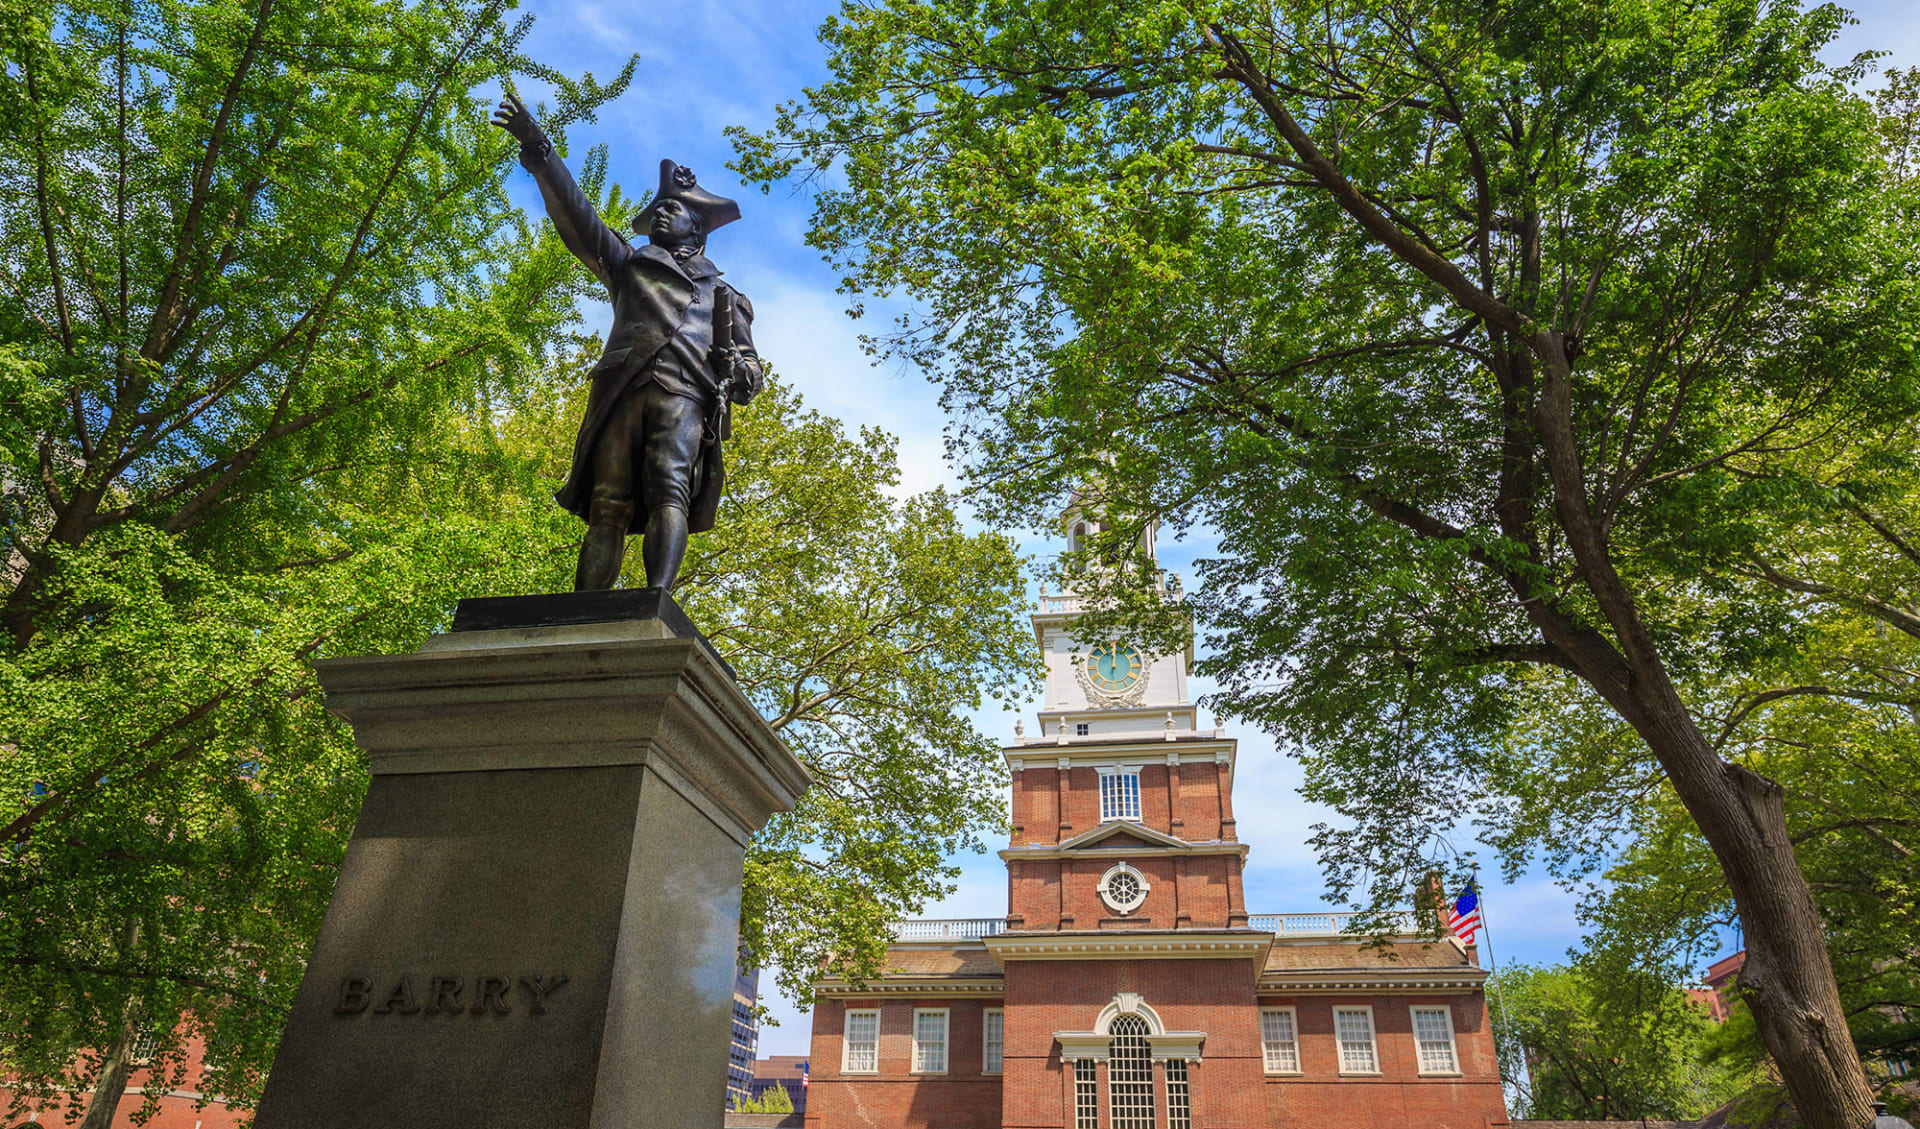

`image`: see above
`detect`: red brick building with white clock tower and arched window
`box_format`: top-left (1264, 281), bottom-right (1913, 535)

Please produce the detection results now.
top-left (804, 509), bottom-right (1507, 1129)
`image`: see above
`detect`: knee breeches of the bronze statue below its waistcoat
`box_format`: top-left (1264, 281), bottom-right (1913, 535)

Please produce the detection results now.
top-left (589, 380), bottom-right (707, 520)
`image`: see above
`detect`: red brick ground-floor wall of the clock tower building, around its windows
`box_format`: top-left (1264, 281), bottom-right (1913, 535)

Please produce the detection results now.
top-left (806, 975), bottom-right (1507, 1129)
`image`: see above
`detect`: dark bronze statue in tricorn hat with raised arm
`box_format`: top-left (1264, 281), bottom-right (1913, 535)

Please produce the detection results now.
top-left (493, 94), bottom-right (762, 591)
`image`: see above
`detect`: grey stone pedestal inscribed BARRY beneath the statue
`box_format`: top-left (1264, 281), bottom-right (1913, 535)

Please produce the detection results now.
top-left (255, 589), bottom-right (808, 1129)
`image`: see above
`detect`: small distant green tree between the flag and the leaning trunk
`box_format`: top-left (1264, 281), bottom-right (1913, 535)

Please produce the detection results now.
top-left (1488, 964), bottom-right (1757, 1121)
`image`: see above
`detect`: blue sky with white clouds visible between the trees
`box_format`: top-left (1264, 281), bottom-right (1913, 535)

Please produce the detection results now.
top-left (511, 0), bottom-right (1920, 1054)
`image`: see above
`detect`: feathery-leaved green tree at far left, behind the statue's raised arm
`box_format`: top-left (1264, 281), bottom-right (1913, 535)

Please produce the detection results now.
top-left (0, 0), bottom-right (626, 1129)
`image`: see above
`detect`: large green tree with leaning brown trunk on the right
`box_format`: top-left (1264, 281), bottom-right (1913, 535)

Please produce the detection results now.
top-left (739, 0), bottom-right (1920, 1129)
